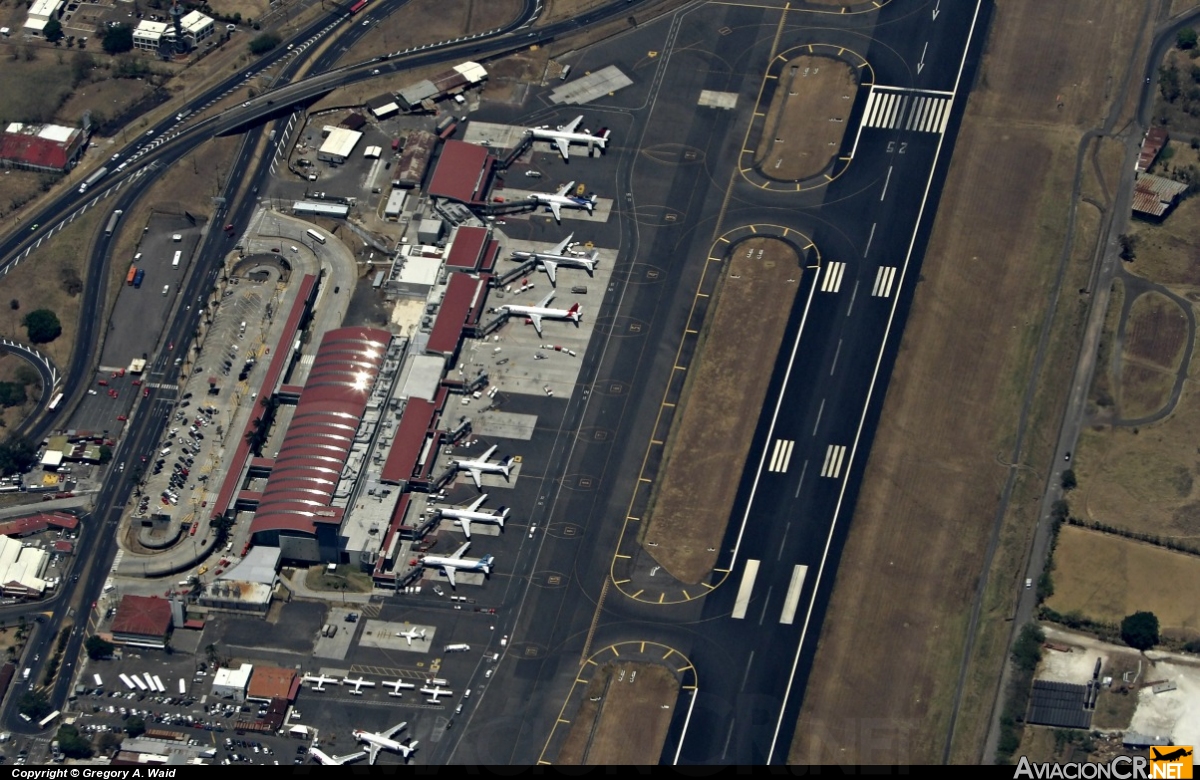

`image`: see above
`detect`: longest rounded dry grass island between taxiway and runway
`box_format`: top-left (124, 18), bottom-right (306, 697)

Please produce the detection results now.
top-left (641, 239), bottom-right (802, 584)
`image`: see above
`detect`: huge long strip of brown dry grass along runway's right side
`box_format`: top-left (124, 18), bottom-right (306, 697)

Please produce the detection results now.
top-left (791, 0), bottom-right (1141, 766)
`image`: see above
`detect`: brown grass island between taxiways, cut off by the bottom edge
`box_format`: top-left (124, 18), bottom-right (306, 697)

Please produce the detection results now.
top-left (556, 662), bottom-right (679, 767)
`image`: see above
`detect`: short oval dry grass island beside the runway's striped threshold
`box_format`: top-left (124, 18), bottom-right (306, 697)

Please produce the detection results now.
top-left (755, 55), bottom-right (858, 181)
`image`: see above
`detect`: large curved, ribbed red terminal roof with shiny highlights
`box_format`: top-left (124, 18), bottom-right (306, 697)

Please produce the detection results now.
top-left (250, 328), bottom-right (391, 534)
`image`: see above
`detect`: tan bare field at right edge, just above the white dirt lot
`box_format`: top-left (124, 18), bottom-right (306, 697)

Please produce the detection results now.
top-left (1046, 526), bottom-right (1200, 638)
